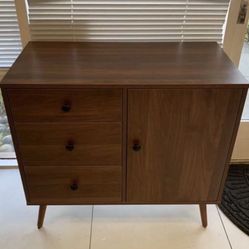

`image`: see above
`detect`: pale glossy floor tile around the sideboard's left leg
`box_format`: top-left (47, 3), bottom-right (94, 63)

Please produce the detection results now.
top-left (0, 170), bottom-right (92, 249)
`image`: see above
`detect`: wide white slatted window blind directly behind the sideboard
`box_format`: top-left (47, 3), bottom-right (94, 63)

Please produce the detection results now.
top-left (29, 0), bottom-right (229, 43)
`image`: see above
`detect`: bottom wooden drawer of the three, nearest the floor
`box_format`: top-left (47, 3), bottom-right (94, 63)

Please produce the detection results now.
top-left (25, 166), bottom-right (121, 205)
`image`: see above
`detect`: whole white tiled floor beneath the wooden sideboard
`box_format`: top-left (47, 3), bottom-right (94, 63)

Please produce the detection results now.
top-left (0, 169), bottom-right (249, 249)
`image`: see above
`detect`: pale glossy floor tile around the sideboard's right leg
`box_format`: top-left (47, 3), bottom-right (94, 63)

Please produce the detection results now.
top-left (91, 205), bottom-right (230, 249)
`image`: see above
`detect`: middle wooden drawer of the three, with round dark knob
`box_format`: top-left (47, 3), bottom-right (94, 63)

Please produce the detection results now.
top-left (15, 122), bottom-right (122, 166)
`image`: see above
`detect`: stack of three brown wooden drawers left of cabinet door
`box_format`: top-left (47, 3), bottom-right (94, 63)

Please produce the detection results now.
top-left (7, 89), bottom-right (122, 205)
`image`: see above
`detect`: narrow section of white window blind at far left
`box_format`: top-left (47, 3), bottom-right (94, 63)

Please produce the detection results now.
top-left (0, 0), bottom-right (22, 68)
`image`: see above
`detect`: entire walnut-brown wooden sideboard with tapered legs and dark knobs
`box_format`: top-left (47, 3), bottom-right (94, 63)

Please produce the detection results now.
top-left (1, 42), bottom-right (248, 228)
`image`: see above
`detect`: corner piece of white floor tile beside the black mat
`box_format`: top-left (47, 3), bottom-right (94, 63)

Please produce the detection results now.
top-left (219, 210), bottom-right (249, 249)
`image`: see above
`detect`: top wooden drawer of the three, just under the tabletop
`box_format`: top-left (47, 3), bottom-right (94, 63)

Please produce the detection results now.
top-left (8, 89), bottom-right (122, 122)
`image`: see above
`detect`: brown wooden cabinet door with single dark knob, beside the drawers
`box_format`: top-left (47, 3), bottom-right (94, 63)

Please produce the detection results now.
top-left (127, 88), bottom-right (242, 203)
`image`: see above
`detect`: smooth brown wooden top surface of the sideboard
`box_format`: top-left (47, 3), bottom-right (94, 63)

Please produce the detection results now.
top-left (1, 42), bottom-right (248, 88)
